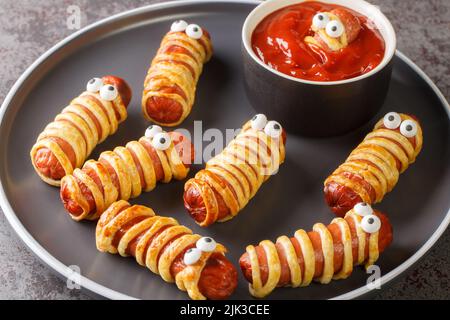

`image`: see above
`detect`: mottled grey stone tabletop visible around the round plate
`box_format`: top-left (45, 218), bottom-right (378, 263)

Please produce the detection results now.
top-left (0, 0), bottom-right (450, 299)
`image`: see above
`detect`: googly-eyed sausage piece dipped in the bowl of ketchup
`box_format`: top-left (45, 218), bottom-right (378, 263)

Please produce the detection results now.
top-left (305, 8), bottom-right (361, 51)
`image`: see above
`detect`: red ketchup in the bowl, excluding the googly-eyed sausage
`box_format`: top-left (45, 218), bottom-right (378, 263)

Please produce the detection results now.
top-left (252, 1), bottom-right (385, 81)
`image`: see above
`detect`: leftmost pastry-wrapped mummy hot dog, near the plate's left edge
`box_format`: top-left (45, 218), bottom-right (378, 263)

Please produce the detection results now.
top-left (30, 76), bottom-right (131, 186)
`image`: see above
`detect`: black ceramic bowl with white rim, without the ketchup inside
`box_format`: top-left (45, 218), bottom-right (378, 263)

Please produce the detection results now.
top-left (242, 0), bottom-right (397, 137)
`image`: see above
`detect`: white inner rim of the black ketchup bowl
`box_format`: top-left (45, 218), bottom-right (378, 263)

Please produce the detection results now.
top-left (242, 0), bottom-right (397, 86)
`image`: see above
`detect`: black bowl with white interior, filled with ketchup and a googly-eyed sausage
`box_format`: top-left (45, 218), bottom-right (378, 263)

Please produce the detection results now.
top-left (242, 0), bottom-right (397, 137)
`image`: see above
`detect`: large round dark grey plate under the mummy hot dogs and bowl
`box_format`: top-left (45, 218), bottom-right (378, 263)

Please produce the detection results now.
top-left (0, 1), bottom-right (450, 299)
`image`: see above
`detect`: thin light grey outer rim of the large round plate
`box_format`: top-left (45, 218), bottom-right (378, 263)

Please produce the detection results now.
top-left (0, 0), bottom-right (450, 300)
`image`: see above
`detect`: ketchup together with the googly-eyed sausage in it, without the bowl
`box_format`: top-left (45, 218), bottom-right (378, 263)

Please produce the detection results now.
top-left (252, 1), bottom-right (385, 81)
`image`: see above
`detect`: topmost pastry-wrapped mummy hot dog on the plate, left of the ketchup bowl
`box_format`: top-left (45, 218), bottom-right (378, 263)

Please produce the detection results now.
top-left (142, 20), bottom-right (212, 126)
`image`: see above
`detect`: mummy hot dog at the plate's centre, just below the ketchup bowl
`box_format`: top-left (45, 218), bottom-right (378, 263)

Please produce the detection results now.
top-left (184, 114), bottom-right (286, 227)
